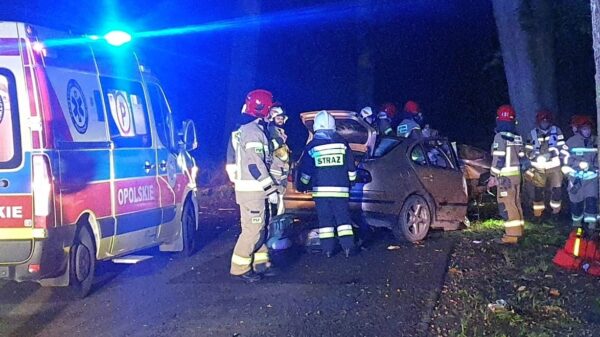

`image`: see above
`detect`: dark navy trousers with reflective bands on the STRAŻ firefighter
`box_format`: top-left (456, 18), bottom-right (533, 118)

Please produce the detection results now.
top-left (314, 198), bottom-right (354, 252)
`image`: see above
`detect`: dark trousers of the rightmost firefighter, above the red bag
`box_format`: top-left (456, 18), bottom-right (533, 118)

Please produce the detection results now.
top-left (568, 177), bottom-right (598, 230)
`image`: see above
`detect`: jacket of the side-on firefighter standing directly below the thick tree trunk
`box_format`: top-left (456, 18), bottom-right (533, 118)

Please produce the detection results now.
top-left (490, 131), bottom-right (525, 177)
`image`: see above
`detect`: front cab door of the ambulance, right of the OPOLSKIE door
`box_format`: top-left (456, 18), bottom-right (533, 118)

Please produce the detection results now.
top-left (146, 82), bottom-right (183, 242)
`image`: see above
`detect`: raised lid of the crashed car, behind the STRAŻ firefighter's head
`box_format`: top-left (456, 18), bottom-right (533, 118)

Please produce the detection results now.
top-left (300, 110), bottom-right (375, 155)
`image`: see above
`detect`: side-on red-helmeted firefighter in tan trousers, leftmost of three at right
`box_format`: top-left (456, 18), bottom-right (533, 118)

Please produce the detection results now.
top-left (489, 105), bottom-right (525, 244)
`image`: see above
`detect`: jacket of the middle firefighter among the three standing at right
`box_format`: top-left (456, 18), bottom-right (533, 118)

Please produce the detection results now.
top-left (525, 125), bottom-right (565, 171)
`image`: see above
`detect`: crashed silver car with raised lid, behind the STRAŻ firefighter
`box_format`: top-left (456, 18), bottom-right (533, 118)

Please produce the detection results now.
top-left (284, 110), bottom-right (468, 242)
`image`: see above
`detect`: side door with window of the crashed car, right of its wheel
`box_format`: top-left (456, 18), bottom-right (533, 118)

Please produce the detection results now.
top-left (409, 139), bottom-right (467, 221)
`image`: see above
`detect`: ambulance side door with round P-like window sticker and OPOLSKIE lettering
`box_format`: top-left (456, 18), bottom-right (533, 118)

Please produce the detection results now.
top-left (101, 77), bottom-right (162, 255)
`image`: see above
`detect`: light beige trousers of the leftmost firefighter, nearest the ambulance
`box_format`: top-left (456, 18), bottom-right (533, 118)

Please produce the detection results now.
top-left (230, 199), bottom-right (270, 275)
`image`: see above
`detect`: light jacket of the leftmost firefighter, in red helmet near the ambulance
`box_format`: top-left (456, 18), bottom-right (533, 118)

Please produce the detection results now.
top-left (226, 119), bottom-right (276, 202)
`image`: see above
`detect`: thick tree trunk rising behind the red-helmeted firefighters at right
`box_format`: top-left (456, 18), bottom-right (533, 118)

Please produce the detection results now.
top-left (492, 0), bottom-right (557, 135)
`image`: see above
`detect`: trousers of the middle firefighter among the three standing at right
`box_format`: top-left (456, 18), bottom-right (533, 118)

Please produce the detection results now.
top-left (533, 167), bottom-right (563, 217)
